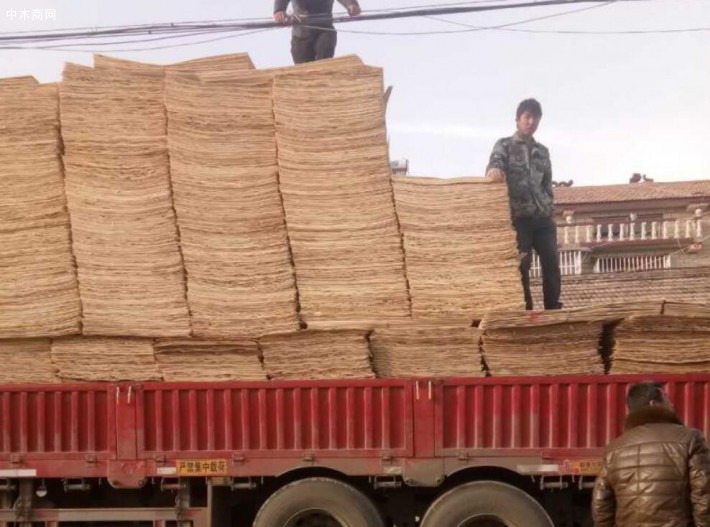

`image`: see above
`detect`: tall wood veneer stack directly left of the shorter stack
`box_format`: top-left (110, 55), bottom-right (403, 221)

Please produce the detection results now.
top-left (274, 66), bottom-right (410, 324)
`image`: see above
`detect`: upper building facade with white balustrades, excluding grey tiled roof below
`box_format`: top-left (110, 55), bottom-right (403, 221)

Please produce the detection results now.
top-left (533, 181), bottom-right (710, 276)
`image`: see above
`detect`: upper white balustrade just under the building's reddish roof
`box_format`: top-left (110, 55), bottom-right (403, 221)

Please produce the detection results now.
top-left (557, 218), bottom-right (703, 245)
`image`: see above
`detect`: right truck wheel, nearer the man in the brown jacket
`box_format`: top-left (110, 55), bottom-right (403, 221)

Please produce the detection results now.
top-left (421, 481), bottom-right (553, 527)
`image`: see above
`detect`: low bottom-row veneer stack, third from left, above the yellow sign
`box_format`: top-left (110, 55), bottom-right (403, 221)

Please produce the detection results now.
top-left (154, 339), bottom-right (266, 381)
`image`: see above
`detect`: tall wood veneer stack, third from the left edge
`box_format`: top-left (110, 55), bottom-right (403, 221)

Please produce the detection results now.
top-left (166, 72), bottom-right (299, 338)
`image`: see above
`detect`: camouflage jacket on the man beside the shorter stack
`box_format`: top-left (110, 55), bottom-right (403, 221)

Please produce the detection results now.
top-left (488, 134), bottom-right (555, 219)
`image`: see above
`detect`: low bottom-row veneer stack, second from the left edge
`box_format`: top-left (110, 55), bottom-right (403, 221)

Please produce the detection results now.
top-left (52, 337), bottom-right (162, 382)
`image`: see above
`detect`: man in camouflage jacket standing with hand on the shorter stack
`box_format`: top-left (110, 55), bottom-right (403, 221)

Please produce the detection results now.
top-left (486, 99), bottom-right (562, 310)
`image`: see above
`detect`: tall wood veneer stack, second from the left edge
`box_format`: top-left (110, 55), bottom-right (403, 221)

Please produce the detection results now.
top-left (60, 64), bottom-right (190, 337)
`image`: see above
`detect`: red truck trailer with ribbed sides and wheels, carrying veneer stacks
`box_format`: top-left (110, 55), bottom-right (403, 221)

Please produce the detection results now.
top-left (0, 374), bottom-right (710, 527)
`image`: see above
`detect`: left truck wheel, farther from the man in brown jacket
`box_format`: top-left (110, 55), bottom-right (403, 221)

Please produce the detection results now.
top-left (253, 478), bottom-right (385, 527)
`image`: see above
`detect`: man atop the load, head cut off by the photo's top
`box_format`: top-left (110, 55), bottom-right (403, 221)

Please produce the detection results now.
top-left (274, 0), bottom-right (360, 64)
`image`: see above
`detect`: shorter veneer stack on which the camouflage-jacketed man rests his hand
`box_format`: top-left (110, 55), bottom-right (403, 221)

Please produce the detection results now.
top-left (393, 176), bottom-right (524, 319)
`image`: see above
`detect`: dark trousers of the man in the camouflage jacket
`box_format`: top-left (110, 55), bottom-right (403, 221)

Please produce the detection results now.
top-left (513, 218), bottom-right (562, 310)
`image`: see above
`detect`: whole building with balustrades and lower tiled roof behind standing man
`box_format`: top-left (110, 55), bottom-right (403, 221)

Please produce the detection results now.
top-left (532, 180), bottom-right (710, 308)
